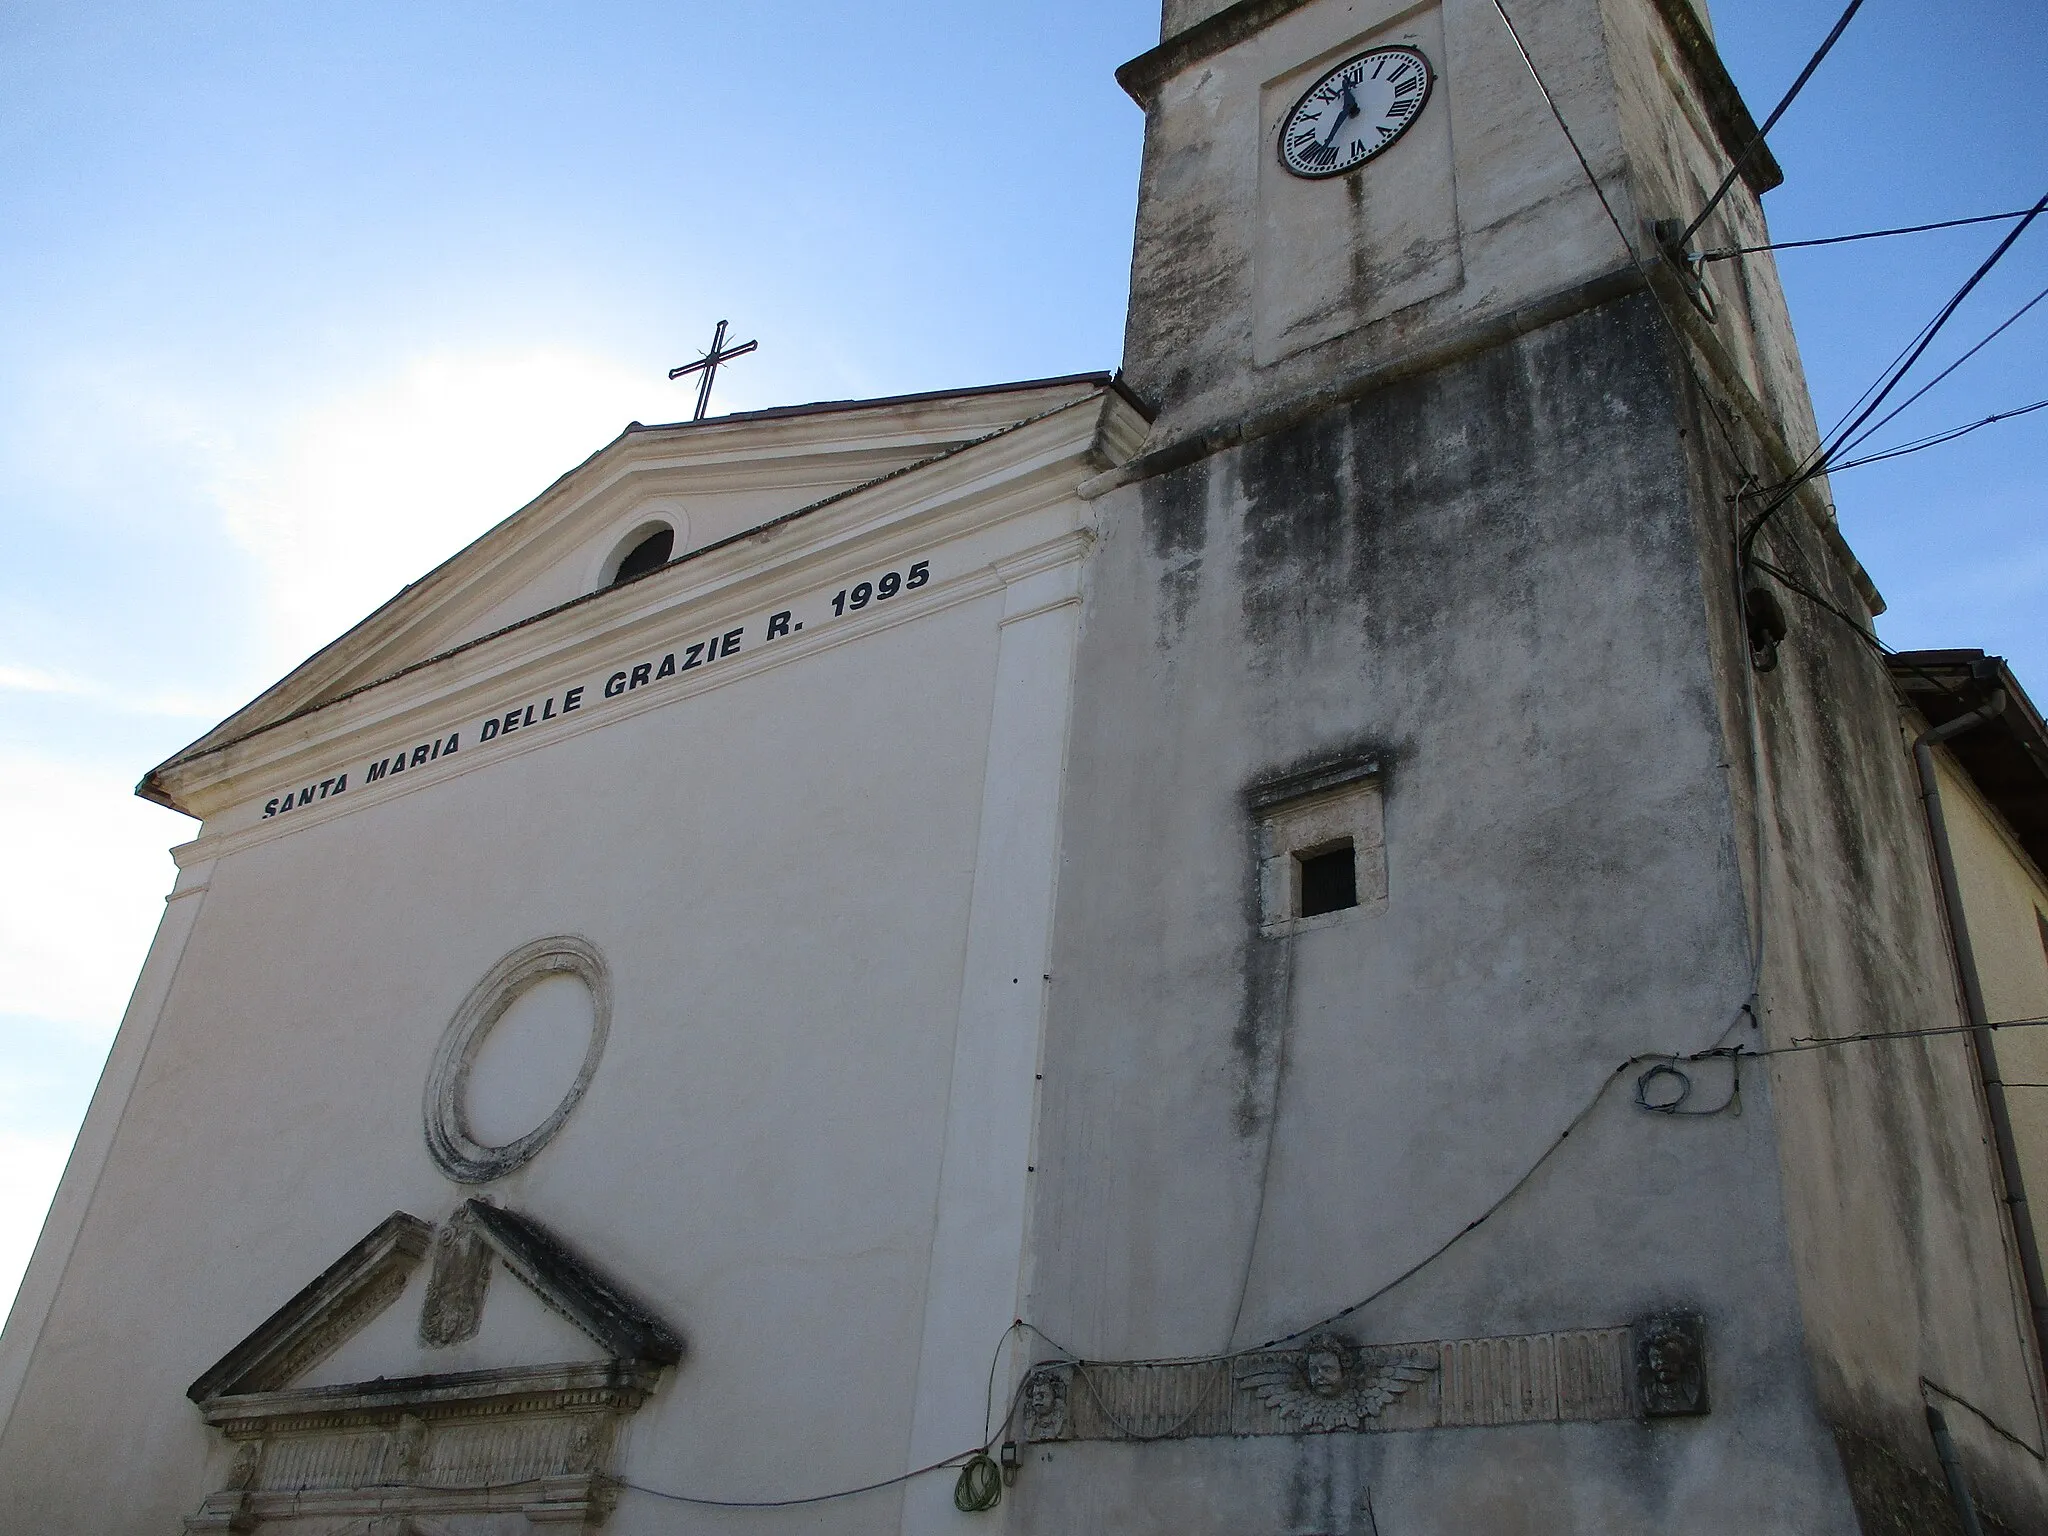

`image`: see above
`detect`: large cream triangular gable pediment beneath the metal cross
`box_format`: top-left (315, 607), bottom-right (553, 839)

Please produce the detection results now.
top-left (139, 375), bottom-right (1137, 809)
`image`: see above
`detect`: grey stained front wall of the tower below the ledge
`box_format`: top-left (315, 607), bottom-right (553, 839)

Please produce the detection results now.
top-left (1020, 295), bottom-right (1855, 1536)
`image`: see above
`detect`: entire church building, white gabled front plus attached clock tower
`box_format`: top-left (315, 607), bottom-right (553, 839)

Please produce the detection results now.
top-left (0, 0), bottom-right (2048, 1536)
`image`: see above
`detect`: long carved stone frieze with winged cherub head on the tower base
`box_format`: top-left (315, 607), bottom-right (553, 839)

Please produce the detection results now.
top-left (1024, 1319), bottom-right (1679, 1442)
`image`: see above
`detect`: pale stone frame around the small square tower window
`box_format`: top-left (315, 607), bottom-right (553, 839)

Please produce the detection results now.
top-left (1247, 758), bottom-right (1386, 938)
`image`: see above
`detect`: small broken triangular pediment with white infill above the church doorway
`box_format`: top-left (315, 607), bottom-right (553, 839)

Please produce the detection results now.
top-left (186, 1200), bottom-right (682, 1413)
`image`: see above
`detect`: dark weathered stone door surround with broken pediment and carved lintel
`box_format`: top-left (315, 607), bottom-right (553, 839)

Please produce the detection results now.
top-left (184, 1200), bottom-right (682, 1536)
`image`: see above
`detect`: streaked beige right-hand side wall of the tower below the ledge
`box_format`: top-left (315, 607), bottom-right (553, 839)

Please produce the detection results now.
top-left (1690, 352), bottom-right (2048, 1530)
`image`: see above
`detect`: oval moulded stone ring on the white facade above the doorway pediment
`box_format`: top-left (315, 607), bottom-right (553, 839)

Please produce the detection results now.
top-left (424, 934), bottom-right (612, 1184)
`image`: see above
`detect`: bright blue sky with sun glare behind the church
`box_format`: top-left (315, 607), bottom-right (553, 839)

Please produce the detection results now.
top-left (0, 0), bottom-right (2048, 1296)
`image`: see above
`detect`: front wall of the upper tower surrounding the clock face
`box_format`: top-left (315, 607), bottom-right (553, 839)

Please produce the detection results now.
top-left (1124, 0), bottom-right (1638, 456)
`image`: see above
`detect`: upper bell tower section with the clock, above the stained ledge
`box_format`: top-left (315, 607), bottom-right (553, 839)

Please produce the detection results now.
top-left (1118, 0), bottom-right (1812, 475)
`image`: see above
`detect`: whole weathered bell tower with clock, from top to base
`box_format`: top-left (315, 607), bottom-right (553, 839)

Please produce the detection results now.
top-left (1018, 0), bottom-right (2048, 1536)
